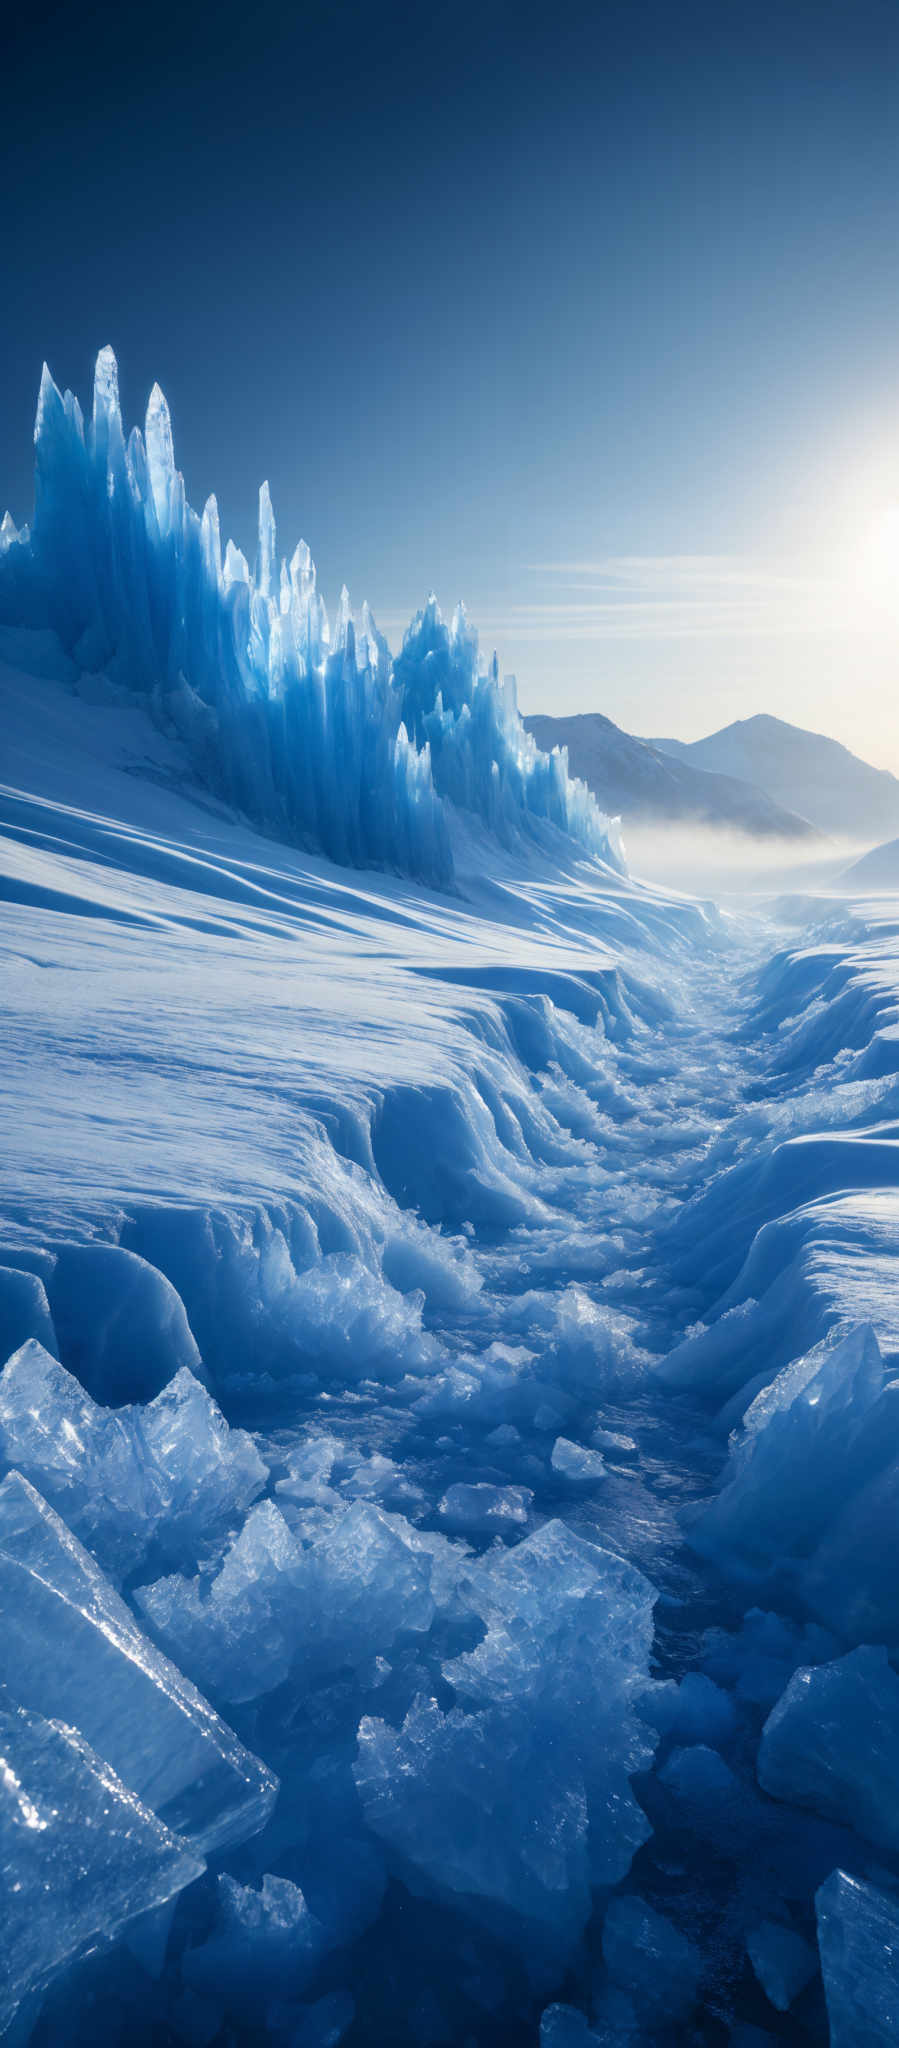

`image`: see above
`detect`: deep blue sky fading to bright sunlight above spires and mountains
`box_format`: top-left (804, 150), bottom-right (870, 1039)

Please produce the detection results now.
top-left (0, 0), bottom-right (899, 766)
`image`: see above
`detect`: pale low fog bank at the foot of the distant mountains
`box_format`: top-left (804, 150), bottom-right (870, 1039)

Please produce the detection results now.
top-left (623, 823), bottom-right (872, 897)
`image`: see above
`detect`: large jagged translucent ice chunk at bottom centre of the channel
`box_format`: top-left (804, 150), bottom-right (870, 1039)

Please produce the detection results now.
top-left (354, 1522), bottom-right (655, 1939)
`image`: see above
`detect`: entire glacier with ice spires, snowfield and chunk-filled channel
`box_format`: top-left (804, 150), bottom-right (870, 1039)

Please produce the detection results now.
top-left (0, 352), bottom-right (899, 2048)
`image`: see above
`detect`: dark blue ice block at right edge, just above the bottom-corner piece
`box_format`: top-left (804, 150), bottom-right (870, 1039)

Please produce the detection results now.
top-left (758, 1647), bottom-right (899, 1851)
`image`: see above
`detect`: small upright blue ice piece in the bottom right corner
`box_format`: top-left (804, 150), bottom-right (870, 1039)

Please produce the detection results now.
top-left (815, 1870), bottom-right (899, 2048)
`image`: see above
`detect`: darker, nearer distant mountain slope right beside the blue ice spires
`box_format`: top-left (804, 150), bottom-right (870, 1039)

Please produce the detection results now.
top-left (524, 711), bottom-right (817, 840)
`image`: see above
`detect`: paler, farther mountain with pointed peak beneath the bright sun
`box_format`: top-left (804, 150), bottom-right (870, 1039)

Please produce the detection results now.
top-left (649, 713), bottom-right (899, 840)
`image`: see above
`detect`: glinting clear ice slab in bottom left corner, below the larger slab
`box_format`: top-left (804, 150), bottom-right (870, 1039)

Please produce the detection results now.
top-left (0, 1706), bottom-right (205, 2032)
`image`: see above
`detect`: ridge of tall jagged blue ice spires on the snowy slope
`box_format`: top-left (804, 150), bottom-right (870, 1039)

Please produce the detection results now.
top-left (0, 348), bottom-right (620, 885)
